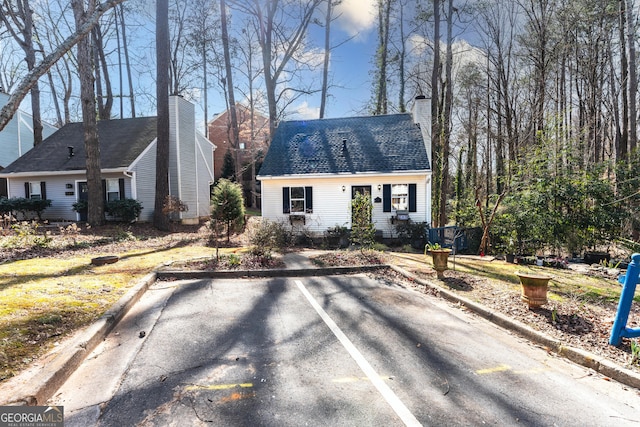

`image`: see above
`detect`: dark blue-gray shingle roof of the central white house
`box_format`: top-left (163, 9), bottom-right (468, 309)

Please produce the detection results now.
top-left (259, 114), bottom-right (429, 177)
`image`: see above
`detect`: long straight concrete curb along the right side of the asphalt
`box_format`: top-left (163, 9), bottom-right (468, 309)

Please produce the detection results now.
top-left (390, 265), bottom-right (640, 389)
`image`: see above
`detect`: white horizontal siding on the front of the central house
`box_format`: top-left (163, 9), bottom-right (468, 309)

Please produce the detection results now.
top-left (261, 172), bottom-right (431, 237)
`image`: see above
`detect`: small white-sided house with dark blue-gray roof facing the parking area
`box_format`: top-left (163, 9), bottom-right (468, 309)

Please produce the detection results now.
top-left (258, 98), bottom-right (431, 237)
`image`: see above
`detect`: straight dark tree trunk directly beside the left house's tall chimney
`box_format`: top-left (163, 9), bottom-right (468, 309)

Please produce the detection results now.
top-left (153, 0), bottom-right (170, 231)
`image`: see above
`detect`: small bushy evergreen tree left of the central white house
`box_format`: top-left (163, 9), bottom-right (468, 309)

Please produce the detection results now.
top-left (211, 178), bottom-right (244, 242)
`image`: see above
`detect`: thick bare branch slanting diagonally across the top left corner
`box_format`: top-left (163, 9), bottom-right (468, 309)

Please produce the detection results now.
top-left (0, 0), bottom-right (125, 131)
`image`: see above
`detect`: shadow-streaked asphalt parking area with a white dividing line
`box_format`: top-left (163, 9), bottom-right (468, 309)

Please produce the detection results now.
top-left (49, 274), bottom-right (640, 426)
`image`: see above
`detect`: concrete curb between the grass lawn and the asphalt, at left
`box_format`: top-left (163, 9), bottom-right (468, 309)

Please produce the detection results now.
top-left (0, 273), bottom-right (156, 406)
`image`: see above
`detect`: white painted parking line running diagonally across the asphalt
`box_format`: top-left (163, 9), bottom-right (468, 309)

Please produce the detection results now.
top-left (295, 280), bottom-right (422, 426)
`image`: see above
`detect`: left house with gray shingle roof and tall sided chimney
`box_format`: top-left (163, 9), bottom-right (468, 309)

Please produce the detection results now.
top-left (0, 96), bottom-right (215, 223)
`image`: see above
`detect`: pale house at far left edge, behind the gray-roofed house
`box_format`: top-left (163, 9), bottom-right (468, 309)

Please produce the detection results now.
top-left (0, 89), bottom-right (58, 197)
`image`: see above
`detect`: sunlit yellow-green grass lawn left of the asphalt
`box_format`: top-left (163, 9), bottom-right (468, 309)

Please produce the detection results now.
top-left (0, 239), bottom-right (228, 381)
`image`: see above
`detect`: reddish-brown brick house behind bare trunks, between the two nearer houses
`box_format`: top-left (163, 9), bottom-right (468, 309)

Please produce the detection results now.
top-left (208, 103), bottom-right (269, 205)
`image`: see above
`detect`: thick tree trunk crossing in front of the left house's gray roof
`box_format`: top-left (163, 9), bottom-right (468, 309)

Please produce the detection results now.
top-left (71, 0), bottom-right (104, 226)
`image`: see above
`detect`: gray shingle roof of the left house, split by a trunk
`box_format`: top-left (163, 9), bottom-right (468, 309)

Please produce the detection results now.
top-left (2, 117), bottom-right (157, 173)
